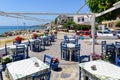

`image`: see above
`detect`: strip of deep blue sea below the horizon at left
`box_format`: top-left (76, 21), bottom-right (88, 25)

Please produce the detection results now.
top-left (0, 26), bottom-right (46, 34)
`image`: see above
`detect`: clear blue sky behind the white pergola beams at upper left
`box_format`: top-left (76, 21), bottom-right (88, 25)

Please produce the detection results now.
top-left (0, 0), bottom-right (90, 26)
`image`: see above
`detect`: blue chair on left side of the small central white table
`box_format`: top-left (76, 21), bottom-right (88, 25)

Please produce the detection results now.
top-left (60, 41), bottom-right (69, 60)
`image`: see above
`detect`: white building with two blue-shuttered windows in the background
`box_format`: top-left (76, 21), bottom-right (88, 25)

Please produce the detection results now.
top-left (73, 15), bottom-right (90, 25)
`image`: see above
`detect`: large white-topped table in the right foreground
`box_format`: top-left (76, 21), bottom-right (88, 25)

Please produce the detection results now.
top-left (79, 60), bottom-right (120, 80)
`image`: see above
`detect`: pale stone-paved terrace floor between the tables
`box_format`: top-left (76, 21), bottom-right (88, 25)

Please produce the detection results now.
top-left (3, 33), bottom-right (120, 80)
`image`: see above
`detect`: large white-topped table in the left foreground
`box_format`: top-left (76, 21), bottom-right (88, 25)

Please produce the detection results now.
top-left (6, 57), bottom-right (49, 80)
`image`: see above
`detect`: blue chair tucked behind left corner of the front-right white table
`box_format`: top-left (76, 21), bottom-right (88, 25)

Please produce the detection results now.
top-left (78, 55), bottom-right (90, 80)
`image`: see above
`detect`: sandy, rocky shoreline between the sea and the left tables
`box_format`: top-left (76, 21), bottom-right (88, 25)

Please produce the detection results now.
top-left (0, 29), bottom-right (45, 47)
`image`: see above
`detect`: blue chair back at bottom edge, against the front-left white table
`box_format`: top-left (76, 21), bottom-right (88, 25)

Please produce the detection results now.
top-left (32, 70), bottom-right (51, 80)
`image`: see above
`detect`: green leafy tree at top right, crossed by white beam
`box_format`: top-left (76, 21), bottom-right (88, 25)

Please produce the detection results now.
top-left (85, 0), bottom-right (120, 22)
